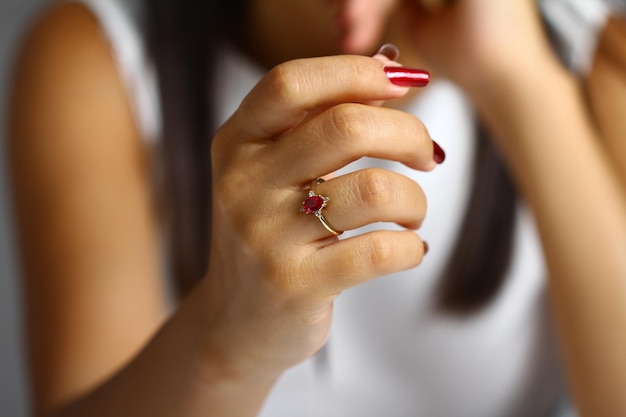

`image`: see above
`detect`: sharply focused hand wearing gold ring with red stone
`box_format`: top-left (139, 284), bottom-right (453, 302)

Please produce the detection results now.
top-left (191, 56), bottom-right (435, 373)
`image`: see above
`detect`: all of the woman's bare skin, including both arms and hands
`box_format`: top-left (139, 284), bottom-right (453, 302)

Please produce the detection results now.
top-left (10, 0), bottom-right (626, 416)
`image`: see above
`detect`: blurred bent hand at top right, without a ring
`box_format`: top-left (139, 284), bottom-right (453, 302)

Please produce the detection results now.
top-left (399, 0), bottom-right (555, 91)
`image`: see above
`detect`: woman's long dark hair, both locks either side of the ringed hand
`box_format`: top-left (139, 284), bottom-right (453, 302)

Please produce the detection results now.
top-left (144, 0), bottom-right (516, 314)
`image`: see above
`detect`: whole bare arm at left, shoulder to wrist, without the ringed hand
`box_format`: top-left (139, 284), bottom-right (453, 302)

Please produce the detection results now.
top-left (10, 5), bottom-right (282, 416)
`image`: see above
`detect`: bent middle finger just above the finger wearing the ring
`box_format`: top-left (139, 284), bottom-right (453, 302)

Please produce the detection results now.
top-left (264, 104), bottom-right (436, 185)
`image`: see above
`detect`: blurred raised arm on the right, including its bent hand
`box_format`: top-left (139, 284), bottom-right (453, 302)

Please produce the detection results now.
top-left (402, 0), bottom-right (626, 416)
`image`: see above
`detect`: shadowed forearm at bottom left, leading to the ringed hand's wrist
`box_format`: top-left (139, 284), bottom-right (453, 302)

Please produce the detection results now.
top-left (44, 282), bottom-right (278, 417)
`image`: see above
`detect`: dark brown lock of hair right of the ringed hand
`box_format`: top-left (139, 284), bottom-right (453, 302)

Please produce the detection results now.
top-left (437, 124), bottom-right (517, 315)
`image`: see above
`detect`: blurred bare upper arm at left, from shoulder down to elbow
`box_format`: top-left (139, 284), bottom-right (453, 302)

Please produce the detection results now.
top-left (9, 4), bottom-right (173, 411)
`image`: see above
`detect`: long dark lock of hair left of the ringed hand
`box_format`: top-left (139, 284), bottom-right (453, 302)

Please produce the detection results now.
top-left (143, 0), bottom-right (244, 295)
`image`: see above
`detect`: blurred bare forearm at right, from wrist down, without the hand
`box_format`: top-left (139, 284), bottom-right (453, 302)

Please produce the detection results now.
top-left (473, 60), bottom-right (626, 416)
